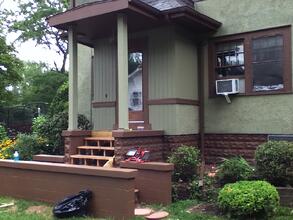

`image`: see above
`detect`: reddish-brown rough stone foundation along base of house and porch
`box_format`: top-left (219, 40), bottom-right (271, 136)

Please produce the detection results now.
top-left (63, 130), bottom-right (268, 165)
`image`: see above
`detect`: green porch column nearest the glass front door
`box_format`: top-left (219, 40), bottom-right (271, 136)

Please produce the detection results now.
top-left (117, 14), bottom-right (128, 129)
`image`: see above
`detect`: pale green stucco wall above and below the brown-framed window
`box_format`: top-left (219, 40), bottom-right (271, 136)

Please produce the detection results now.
top-left (197, 0), bottom-right (293, 134)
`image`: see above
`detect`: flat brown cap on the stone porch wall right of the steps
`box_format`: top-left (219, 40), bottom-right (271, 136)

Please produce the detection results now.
top-left (113, 130), bottom-right (164, 138)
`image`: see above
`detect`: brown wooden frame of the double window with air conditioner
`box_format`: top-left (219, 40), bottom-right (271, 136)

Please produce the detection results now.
top-left (208, 26), bottom-right (292, 97)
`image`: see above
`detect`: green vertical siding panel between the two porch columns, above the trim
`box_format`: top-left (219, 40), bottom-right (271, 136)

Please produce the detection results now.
top-left (94, 40), bottom-right (117, 102)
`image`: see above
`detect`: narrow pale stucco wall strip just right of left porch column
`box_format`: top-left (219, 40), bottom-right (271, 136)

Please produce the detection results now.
top-left (78, 44), bottom-right (93, 120)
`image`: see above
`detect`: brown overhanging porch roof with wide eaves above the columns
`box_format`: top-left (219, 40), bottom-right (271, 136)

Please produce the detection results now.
top-left (48, 0), bottom-right (221, 46)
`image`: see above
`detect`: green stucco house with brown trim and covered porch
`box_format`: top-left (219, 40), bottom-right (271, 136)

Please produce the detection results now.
top-left (49, 0), bottom-right (293, 163)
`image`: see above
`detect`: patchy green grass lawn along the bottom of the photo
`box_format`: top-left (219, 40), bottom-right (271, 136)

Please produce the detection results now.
top-left (0, 197), bottom-right (293, 220)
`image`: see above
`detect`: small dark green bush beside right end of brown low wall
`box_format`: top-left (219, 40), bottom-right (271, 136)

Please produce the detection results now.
top-left (168, 145), bottom-right (200, 182)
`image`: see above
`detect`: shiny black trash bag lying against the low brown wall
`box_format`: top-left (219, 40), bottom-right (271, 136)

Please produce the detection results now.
top-left (53, 190), bottom-right (92, 218)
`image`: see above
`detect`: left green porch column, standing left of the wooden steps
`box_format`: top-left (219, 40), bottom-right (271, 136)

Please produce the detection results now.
top-left (68, 26), bottom-right (78, 131)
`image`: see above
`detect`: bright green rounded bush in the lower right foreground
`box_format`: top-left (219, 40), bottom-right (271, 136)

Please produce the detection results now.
top-left (218, 181), bottom-right (280, 219)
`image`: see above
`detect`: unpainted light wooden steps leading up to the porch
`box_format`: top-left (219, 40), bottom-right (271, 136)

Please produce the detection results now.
top-left (70, 131), bottom-right (114, 166)
